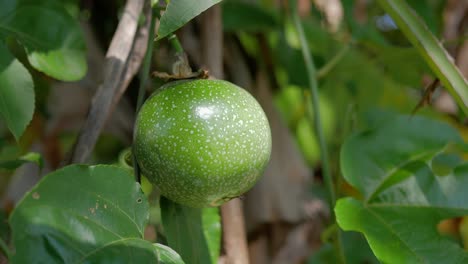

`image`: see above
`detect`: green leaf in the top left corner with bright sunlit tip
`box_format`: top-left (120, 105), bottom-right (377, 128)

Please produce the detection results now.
top-left (0, 0), bottom-right (87, 81)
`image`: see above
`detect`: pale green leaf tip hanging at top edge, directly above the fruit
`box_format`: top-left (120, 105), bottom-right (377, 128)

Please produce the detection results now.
top-left (157, 0), bottom-right (221, 40)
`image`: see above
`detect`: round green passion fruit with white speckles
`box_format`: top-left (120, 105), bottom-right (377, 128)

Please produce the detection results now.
top-left (134, 80), bottom-right (271, 207)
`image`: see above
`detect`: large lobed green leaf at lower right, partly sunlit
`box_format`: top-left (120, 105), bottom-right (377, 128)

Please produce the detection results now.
top-left (335, 116), bottom-right (468, 263)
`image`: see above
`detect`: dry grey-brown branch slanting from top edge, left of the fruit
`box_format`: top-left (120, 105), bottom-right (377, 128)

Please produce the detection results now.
top-left (69, 0), bottom-right (145, 163)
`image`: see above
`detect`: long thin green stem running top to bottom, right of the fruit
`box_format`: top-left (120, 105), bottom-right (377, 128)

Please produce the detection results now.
top-left (291, 1), bottom-right (346, 263)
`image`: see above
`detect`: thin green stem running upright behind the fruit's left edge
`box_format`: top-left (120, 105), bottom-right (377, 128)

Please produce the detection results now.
top-left (132, 9), bottom-right (159, 183)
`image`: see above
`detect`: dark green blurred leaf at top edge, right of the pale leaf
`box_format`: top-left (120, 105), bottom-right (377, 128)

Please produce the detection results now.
top-left (222, 1), bottom-right (279, 32)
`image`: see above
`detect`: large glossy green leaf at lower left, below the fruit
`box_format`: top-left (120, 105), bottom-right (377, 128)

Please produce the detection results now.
top-left (10, 165), bottom-right (157, 263)
